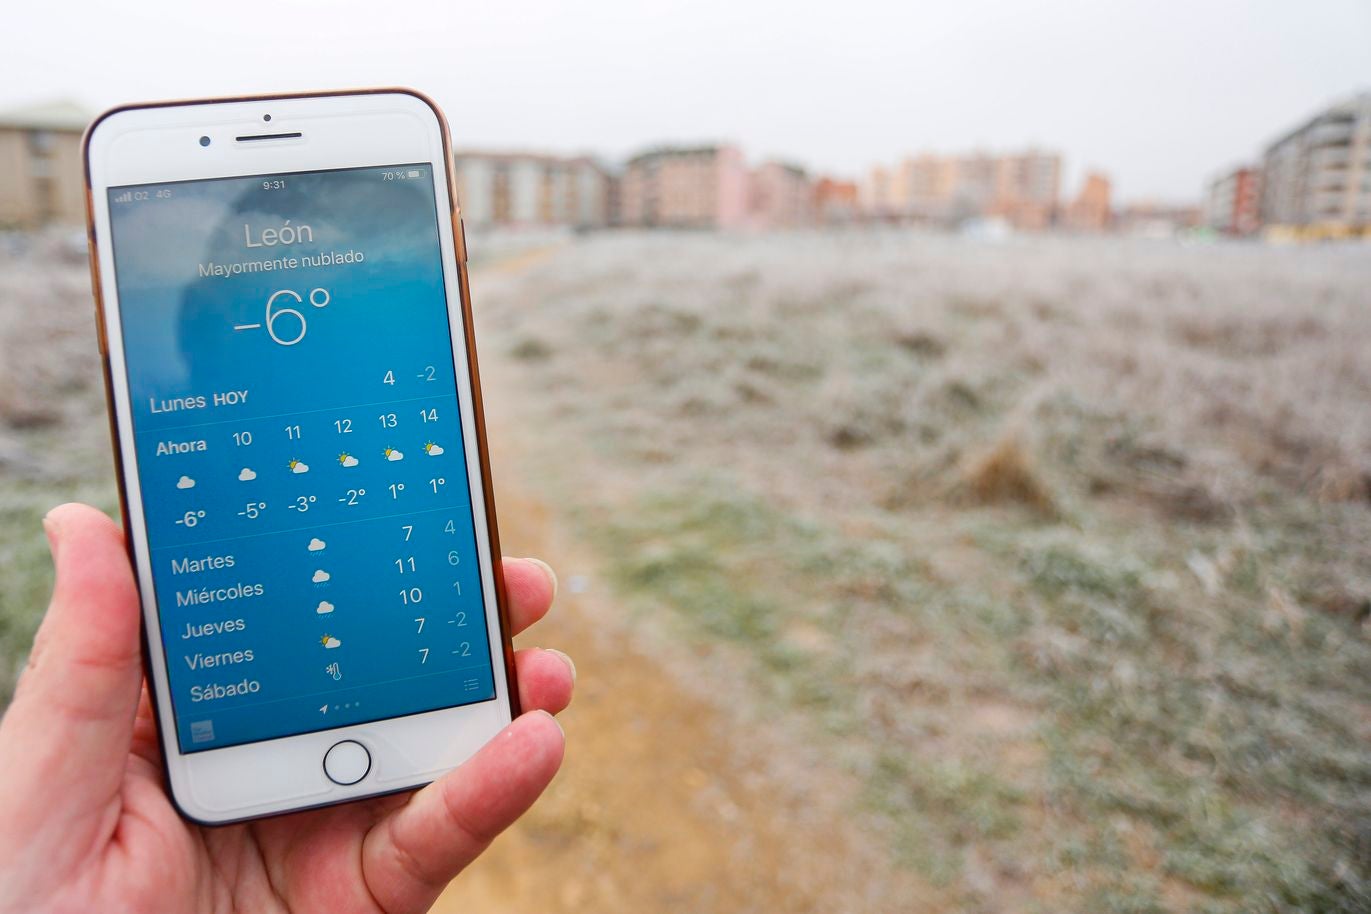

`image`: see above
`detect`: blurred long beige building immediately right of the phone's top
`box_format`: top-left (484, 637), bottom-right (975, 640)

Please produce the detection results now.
top-left (455, 151), bottom-right (614, 229)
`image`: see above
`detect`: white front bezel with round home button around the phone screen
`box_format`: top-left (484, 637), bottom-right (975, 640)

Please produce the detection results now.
top-left (84, 89), bottom-right (520, 825)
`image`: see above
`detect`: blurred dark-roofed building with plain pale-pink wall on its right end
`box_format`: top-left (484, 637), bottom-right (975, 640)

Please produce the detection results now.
top-left (620, 145), bottom-right (751, 229)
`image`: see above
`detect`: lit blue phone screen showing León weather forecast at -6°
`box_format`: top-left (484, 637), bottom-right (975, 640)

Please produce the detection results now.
top-left (108, 163), bottom-right (495, 752)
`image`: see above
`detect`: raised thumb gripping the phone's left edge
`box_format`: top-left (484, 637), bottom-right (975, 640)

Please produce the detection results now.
top-left (0, 504), bottom-right (143, 824)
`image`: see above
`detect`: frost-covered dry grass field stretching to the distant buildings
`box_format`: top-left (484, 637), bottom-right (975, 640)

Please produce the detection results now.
top-left (0, 232), bottom-right (1371, 914)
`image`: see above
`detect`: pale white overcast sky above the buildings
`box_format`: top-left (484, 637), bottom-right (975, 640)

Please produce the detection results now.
top-left (0, 0), bottom-right (1371, 200)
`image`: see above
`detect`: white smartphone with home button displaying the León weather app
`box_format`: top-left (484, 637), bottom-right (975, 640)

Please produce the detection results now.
top-left (85, 89), bottom-right (518, 824)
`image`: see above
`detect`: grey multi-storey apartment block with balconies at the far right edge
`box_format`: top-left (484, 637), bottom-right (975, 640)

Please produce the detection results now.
top-left (1260, 92), bottom-right (1371, 236)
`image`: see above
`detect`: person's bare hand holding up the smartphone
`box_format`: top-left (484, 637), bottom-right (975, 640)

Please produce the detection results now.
top-left (0, 504), bottom-right (576, 914)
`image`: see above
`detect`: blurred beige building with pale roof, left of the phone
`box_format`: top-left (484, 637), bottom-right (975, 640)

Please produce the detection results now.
top-left (0, 101), bottom-right (90, 229)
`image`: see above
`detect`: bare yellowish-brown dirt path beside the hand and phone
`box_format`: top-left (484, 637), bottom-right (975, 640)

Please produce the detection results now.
top-left (435, 253), bottom-right (927, 914)
